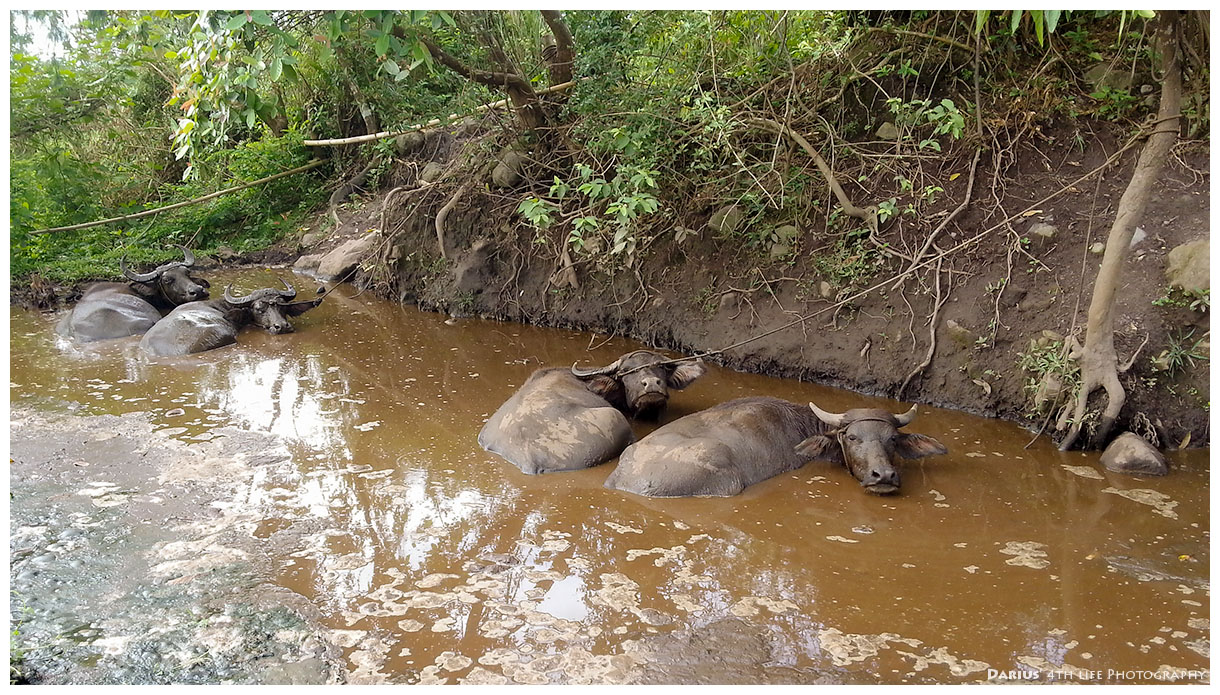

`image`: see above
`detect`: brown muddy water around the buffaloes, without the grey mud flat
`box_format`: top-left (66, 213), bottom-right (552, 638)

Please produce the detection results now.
top-left (10, 271), bottom-right (1210, 683)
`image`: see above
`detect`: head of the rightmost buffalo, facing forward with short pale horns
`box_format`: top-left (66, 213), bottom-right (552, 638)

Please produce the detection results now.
top-left (797, 404), bottom-right (949, 495)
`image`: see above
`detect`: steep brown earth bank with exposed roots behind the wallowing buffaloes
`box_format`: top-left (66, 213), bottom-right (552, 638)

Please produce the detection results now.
top-left (301, 132), bottom-right (1210, 447)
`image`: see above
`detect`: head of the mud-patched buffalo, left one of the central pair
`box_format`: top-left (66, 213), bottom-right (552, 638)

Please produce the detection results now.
top-left (572, 350), bottom-right (708, 418)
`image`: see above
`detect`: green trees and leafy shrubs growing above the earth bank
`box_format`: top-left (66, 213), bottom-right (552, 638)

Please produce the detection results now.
top-left (10, 10), bottom-right (1208, 296)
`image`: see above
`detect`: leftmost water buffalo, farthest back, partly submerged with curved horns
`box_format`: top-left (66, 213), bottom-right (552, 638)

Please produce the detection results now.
top-left (55, 244), bottom-right (211, 343)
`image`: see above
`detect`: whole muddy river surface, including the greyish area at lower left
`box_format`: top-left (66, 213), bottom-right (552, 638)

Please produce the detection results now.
top-left (10, 269), bottom-right (1210, 683)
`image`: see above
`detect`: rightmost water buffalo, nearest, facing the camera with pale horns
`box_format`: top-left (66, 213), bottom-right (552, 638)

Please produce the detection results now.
top-left (605, 397), bottom-right (948, 497)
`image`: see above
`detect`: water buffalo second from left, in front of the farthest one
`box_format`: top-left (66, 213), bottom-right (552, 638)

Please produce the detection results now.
top-left (140, 280), bottom-right (322, 357)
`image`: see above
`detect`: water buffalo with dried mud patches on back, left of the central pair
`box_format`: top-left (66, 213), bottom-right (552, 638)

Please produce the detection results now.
top-left (478, 350), bottom-right (706, 474)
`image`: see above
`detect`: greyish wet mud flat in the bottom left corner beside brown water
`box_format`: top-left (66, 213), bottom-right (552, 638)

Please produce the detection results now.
top-left (10, 408), bottom-right (344, 684)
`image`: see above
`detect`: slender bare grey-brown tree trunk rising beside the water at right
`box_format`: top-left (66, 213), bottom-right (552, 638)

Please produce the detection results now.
top-left (1057, 10), bottom-right (1182, 451)
